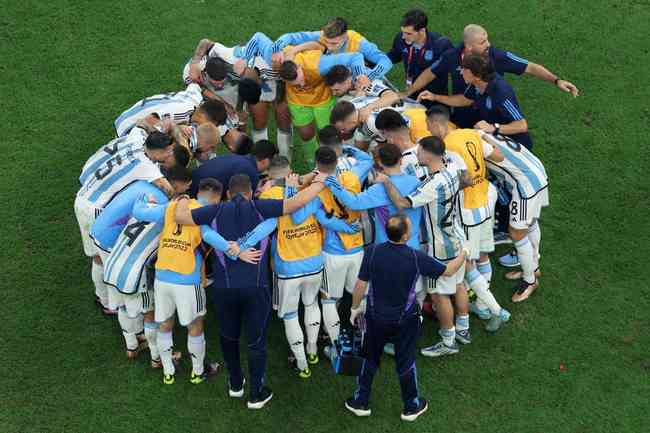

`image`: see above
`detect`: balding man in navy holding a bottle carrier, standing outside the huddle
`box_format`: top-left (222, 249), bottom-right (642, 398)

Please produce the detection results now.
top-left (345, 214), bottom-right (467, 421)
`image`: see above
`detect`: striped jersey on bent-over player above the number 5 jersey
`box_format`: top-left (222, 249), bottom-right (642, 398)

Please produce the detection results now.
top-left (114, 83), bottom-right (203, 137)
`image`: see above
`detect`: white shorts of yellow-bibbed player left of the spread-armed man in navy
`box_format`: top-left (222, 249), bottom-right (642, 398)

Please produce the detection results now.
top-left (154, 280), bottom-right (206, 326)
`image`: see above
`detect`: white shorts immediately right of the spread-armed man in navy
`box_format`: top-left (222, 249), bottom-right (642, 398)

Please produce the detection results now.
top-left (273, 271), bottom-right (323, 318)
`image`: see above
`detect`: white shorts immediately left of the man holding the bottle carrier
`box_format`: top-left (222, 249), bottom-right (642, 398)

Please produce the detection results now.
top-left (322, 250), bottom-right (363, 299)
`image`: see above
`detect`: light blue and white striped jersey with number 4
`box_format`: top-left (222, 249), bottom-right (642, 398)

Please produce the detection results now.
top-left (104, 218), bottom-right (163, 295)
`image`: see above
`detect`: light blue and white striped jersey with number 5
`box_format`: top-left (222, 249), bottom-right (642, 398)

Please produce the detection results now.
top-left (77, 144), bottom-right (163, 208)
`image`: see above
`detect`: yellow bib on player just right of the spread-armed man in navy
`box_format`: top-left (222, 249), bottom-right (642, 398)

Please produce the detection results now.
top-left (260, 186), bottom-right (323, 262)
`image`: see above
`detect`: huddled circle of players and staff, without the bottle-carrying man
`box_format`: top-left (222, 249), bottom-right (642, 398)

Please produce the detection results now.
top-left (74, 10), bottom-right (578, 418)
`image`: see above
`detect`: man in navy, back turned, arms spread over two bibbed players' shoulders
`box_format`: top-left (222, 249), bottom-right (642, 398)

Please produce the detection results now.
top-left (175, 170), bottom-right (325, 409)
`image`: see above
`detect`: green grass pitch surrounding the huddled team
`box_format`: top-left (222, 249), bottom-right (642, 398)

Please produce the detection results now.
top-left (0, 0), bottom-right (650, 433)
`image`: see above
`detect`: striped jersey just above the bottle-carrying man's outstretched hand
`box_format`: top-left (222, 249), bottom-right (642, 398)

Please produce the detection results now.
top-left (406, 164), bottom-right (463, 260)
